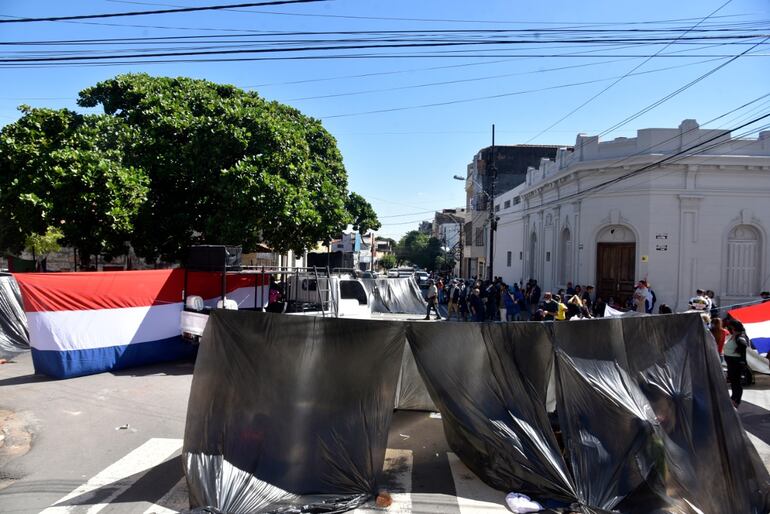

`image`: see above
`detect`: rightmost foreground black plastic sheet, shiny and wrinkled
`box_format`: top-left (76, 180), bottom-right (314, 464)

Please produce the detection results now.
top-left (554, 313), bottom-right (770, 514)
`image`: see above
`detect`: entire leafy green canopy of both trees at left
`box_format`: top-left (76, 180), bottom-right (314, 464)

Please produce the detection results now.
top-left (0, 74), bottom-right (379, 260)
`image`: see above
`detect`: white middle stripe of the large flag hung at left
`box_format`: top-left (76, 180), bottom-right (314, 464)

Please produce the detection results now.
top-left (27, 303), bottom-right (182, 351)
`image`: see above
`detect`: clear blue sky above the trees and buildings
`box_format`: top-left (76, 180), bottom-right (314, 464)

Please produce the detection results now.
top-left (0, 0), bottom-right (770, 238)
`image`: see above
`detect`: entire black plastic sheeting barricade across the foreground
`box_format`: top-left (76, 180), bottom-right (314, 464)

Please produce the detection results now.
top-left (184, 311), bottom-right (770, 514)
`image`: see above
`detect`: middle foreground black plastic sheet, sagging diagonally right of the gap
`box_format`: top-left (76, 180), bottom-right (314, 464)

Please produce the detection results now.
top-left (408, 323), bottom-right (577, 502)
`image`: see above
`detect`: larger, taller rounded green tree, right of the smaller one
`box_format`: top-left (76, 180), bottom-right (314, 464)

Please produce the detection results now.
top-left (79, 74), bottom-right (378, 259)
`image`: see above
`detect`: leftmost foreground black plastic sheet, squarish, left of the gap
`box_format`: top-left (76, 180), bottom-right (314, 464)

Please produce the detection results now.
top-left (183, 310), bottom-right (404, 513)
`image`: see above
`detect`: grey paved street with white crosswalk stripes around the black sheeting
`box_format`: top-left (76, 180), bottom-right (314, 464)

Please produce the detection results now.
top-left (0, 354), bottom-right (770, 514)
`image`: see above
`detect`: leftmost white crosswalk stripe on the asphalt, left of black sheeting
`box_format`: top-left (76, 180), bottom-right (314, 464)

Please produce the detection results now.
top-left (41, 438), bottom-right (182, 514)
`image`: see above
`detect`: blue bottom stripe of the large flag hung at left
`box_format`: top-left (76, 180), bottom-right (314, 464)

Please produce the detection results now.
top-left (32, 336), bottom-right (198, 378)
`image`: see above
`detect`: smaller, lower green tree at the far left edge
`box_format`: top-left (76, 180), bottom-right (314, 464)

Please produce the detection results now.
top-left (0, 106), bottom-right (148, 264)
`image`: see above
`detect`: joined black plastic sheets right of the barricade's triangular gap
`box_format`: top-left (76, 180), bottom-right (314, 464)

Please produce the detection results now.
top-left (409, 314), bottom-right (770, 514)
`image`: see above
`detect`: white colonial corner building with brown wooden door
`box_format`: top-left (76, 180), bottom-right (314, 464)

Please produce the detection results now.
top-left (494, 120), bottom-right (770, 310)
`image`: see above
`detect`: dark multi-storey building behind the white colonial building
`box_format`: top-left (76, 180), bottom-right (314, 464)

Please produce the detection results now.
top-left (460, 145), bottom-right (560, 277)
